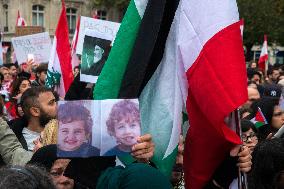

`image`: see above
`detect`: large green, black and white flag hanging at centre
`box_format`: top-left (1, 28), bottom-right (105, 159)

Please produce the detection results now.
top-left (94, 0), bottom-right (180, 176)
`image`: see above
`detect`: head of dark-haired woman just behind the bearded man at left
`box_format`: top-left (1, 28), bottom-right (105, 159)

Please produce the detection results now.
top-left (10, 77), bottom-right (31, 98)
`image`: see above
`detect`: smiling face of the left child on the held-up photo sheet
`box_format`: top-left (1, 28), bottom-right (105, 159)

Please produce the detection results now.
top-left (58, 121), bottom-right (87, 151)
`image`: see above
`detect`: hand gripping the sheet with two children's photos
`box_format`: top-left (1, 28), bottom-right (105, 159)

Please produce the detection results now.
top-left (131, 134), bottom-right (155, 163)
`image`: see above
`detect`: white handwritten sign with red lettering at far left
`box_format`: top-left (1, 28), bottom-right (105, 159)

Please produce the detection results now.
top-left (12, 32), bottom-right (51, 64)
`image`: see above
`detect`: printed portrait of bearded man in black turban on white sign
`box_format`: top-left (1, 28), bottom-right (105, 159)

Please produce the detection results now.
top-left (80, 29), bottom-right (112, 83)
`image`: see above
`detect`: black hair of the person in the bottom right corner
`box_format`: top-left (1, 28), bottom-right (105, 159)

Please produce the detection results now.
top-left (249, 138), bottom-right (284, 189)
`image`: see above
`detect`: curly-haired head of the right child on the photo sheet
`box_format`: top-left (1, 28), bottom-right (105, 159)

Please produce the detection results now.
top-left (106, 100), bottom-right (141, 149)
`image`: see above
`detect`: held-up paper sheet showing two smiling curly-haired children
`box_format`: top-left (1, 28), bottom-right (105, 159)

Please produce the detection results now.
top-left (57, 99), bottom-right (141, 157)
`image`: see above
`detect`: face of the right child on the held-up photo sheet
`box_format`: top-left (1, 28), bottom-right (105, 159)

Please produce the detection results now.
top-left (114, 117), bottom-right (140, 147)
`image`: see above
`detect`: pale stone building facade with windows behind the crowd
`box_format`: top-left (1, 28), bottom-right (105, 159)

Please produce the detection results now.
top-left (0, 0), bottom-right (123, 42)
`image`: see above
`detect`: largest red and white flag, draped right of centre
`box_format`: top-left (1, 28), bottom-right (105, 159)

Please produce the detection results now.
top-left (176, 0), bottom-right (248, 189)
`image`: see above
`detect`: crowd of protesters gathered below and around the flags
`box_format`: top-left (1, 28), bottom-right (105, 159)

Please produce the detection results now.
top-left (0, 58), bottom-right (284, 189)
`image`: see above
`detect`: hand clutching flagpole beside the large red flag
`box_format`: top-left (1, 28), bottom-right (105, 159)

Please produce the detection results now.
top-left (231, 146), bottom-right (252, 173)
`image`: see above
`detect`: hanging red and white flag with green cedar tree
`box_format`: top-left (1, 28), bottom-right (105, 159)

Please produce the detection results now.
top-left (46, 0), bottom-right (73, 98)
